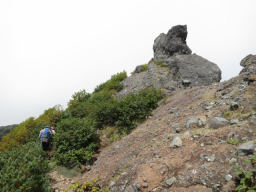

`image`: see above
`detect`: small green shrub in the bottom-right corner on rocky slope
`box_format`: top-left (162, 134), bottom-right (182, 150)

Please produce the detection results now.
top-left (234, 155), bottom-right (256, 192)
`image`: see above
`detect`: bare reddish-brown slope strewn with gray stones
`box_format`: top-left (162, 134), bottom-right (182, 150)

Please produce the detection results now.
top-left (52, 55), bottom-right (256, 192)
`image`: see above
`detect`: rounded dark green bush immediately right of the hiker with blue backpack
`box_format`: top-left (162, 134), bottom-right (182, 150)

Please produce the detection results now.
top-left (54, 118), bottom-right (99, 167)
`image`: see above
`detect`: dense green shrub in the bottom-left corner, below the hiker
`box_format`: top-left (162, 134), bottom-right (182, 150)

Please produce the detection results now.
top-left (0, 142), bottom-right (50, 192)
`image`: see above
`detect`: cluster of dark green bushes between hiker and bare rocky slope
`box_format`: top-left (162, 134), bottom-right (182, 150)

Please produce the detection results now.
top-left (54, 87), bottom-right (163, 167)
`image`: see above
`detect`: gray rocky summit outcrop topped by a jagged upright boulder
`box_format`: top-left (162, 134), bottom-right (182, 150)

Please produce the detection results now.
top-left (118, 25), bottom-right (221, 96)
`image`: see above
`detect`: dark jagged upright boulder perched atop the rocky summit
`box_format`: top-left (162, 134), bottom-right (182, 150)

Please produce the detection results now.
top-left (153, 25), bottom-right (191, 60)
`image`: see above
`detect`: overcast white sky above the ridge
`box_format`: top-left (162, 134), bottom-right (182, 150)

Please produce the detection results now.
top-left (0, 0), bottom-right (256, 126)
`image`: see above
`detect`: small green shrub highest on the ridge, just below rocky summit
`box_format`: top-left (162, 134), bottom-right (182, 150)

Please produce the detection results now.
top-left (94, 71), bottom-right (127, 93)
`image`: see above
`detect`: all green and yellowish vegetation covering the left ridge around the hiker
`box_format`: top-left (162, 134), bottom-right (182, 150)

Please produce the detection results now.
top-left (0, 72), bottom-right (163, 192)
